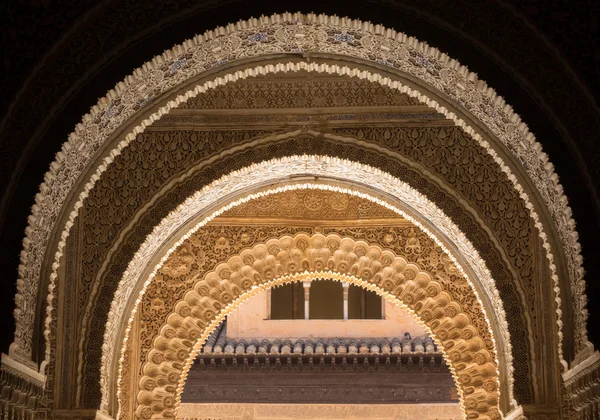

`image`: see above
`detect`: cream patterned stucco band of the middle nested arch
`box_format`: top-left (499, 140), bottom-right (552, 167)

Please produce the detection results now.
top-left (101, 156), bottom-right (512, 416)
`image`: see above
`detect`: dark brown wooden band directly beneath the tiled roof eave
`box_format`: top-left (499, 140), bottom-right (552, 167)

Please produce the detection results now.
top-left (182, 355), bottom-right (458, 407)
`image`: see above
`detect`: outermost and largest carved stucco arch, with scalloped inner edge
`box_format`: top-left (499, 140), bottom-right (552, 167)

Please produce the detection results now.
top-left (3, 9), bottom-right (591, 420)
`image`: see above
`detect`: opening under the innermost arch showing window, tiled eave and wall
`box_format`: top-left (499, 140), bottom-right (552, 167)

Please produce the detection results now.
top-left (178, 276), bottom-right (463, 419)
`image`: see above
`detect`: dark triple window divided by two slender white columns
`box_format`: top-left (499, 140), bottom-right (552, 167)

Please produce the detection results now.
top-left (270, 280), bottom-right (382, 319)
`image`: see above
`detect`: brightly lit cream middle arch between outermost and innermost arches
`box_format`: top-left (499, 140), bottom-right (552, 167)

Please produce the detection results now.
top-left (103, 156), bottom-right (512, 414)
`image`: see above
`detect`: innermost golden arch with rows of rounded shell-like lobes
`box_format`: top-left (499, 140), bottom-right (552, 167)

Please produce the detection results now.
top-left (136, 234), bottom-right (500, 419)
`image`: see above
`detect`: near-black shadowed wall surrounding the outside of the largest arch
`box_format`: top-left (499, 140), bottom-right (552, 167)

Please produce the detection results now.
top-left (0, 0), bottom-right (600, 352)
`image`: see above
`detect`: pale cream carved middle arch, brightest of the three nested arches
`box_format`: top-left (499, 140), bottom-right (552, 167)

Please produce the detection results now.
top-left (101, 156), bottom-right (514, 414)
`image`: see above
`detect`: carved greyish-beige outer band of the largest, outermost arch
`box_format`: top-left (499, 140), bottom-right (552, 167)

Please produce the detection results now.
top-left (15, 15), bottom-right (585, 374)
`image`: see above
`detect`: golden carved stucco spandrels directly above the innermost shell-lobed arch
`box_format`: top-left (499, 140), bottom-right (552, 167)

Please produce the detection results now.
top-left (119, 225), bottom-right (493, 420)
